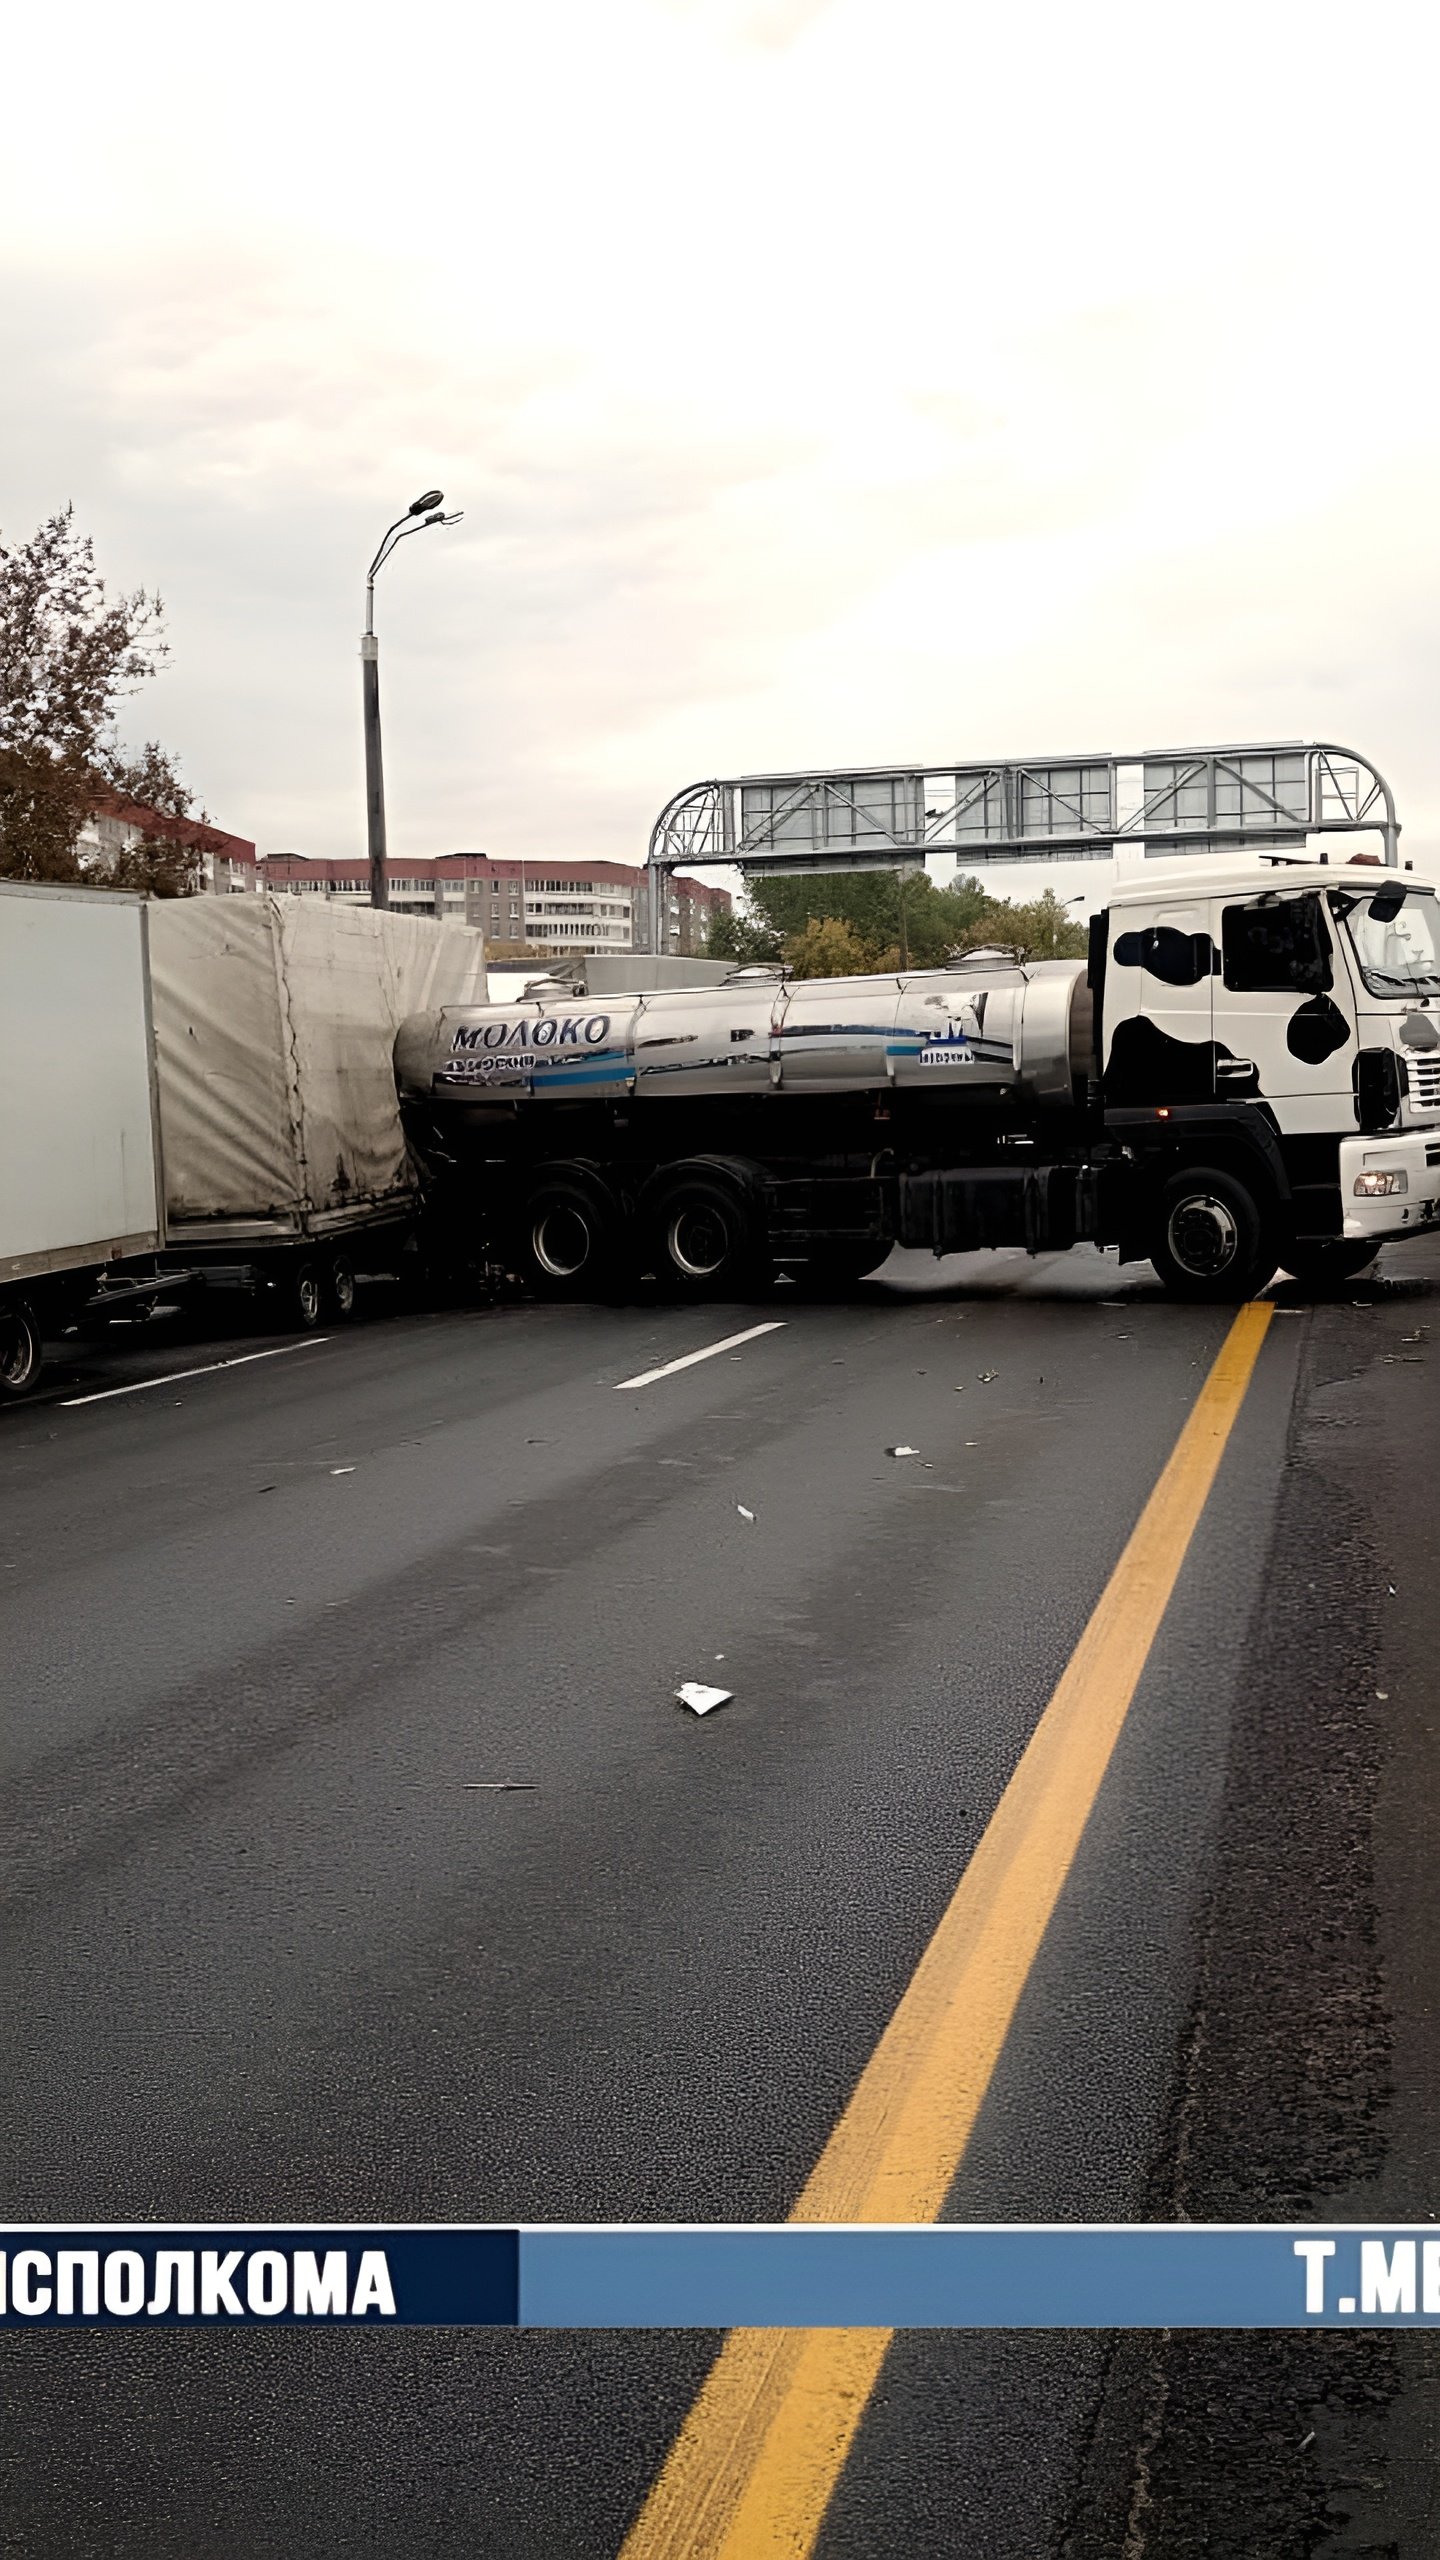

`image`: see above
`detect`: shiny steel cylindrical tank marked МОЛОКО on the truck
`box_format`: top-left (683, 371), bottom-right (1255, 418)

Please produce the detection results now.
top-left (395, 952), bottom-right (1092, 1106)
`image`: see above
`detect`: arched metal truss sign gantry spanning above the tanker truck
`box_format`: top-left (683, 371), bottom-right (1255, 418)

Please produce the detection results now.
top-left (648, 742), bottom-right (1399, 950)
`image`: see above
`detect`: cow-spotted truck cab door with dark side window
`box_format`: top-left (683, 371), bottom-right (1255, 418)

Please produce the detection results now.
top-left (1215, 888), bottom-right (1355, 1132)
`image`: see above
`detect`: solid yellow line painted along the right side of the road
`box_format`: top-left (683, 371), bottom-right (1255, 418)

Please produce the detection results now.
top-left (620, 1303), bottom-right (1271, 2560)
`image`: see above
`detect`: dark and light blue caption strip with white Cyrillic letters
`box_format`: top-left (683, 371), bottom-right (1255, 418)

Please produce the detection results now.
top-left (0, 2222), bottom-right (1440, 2330)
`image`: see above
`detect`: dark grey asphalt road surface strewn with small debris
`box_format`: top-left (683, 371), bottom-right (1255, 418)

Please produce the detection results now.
top-left (0, 1247), bottom-right (1440, 2560)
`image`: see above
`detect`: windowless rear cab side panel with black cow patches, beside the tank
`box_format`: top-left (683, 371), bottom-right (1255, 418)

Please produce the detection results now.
top-left (1104, 899), bottom-right (1217, 1103)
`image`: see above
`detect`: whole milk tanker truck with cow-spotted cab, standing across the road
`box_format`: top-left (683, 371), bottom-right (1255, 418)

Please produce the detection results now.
top-left (395, 860), bottom-right (1440, 1298)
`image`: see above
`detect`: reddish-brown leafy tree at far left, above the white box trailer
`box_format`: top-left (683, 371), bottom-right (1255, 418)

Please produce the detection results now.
top-left (0, 507), bottom-right (200, 896)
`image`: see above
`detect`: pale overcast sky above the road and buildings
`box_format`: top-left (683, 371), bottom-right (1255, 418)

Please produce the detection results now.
top-left (0, 0), bottom-right (1440, 886)
